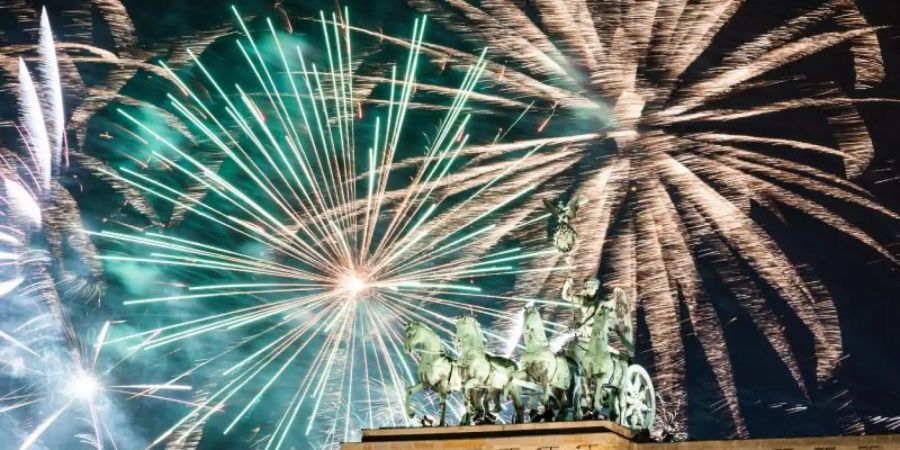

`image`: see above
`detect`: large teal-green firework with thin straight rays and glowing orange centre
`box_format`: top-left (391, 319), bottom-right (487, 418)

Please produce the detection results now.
top-left (88, 11), bottom-right (562, 449)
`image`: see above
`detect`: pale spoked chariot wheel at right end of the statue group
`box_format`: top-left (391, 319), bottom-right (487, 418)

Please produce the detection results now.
top-left (618, 364), bottom-right (656, 430)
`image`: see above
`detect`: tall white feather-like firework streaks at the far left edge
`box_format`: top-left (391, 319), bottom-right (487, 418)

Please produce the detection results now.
top-left (0, 7), bottom-right (103, 304)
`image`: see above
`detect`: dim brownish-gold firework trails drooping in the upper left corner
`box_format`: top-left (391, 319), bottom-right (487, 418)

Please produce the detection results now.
top-left (0, 0), bottom-right (278, 232)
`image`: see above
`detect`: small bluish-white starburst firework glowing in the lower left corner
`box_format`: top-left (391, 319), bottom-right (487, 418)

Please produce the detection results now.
top-left (0, 315), bottom-right (197, 450)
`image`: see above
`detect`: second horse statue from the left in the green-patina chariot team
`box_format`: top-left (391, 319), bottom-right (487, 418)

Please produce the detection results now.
top-left (456, 317), bottom-right (525, 423)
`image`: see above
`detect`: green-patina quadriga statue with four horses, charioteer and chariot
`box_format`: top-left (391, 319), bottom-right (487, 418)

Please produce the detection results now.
top-left (404, 308), bottom-right (656, 430)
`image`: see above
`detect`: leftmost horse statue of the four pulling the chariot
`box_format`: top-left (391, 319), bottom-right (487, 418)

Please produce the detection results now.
top-left (403, 322), bottom-right (469, 426)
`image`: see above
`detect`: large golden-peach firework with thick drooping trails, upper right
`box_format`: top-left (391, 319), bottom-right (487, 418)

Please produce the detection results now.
top-left (400, 0), bottom-right (898, 435)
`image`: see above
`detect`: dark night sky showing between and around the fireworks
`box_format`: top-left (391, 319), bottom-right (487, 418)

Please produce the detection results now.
top-left (0, 0), bottom-right (900, 448)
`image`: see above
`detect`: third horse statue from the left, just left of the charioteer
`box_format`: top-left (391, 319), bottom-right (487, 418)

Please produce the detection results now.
top-left (519, 306), bottom-right (579, 420)
